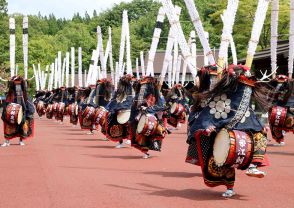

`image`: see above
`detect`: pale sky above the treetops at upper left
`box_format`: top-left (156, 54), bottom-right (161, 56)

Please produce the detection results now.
top-left (8, 0), bottom-right (131, 19)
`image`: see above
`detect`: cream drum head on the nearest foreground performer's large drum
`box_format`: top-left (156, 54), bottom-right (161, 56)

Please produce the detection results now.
top-left (213, 129), bottom-right (230, 166)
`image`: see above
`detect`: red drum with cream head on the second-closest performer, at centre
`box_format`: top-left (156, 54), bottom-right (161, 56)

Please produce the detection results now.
top-left (137, 114), bottom-right (158, 136)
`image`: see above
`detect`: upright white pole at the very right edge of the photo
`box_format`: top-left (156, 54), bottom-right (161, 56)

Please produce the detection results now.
top-left (288, 0), bottom-right (294, 79)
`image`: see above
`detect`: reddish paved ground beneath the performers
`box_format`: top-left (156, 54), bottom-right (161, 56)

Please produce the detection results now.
top-left (0, 119), bottom-right (294, 208)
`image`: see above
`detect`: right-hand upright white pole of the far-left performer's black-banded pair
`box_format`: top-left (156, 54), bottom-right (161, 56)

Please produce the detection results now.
top-left (22, 16), bottom-right (29, 80)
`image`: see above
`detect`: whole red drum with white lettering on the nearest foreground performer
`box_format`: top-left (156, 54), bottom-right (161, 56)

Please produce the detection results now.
top-left (213, 129), bottom-right (254, 170)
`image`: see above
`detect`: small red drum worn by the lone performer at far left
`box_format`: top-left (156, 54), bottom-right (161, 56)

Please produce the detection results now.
top-left (5, 103), bottom-right (23, 124)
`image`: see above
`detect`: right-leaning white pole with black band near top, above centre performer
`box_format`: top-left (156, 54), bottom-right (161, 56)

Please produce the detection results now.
top-left (146, 7), bottom-right (165, 76)
